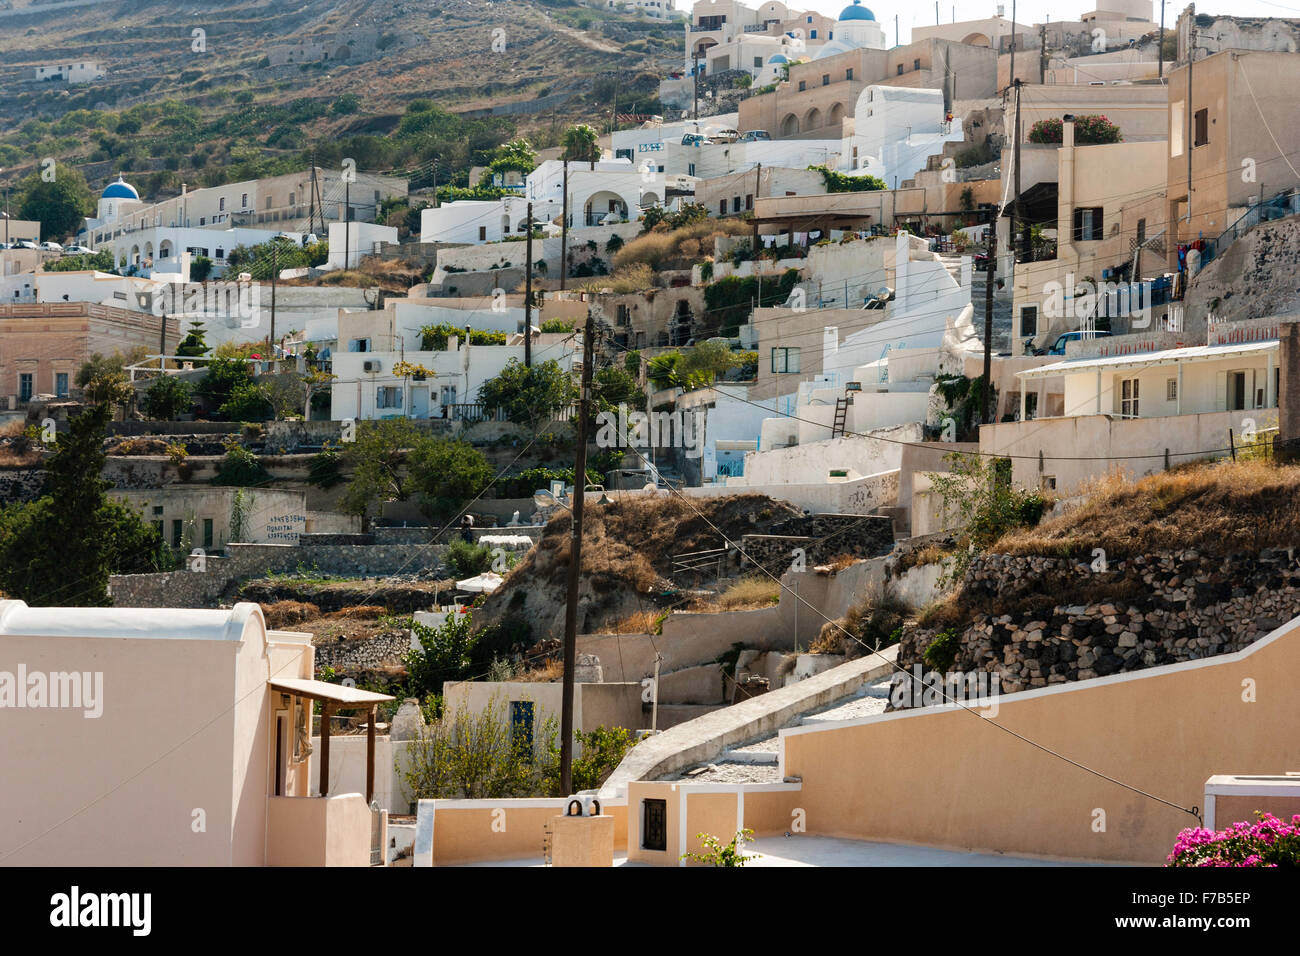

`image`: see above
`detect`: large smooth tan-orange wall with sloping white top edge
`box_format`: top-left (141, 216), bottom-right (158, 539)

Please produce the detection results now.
top-left (774, 619), bottom-right (1300, 865)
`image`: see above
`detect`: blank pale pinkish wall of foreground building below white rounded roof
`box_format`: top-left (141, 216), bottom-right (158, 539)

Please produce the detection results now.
top-left (0, 635), bottom-right (239, 866)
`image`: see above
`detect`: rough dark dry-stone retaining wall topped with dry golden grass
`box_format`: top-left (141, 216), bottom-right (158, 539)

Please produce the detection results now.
top-left (898, 549), bottom-right (1300, 693)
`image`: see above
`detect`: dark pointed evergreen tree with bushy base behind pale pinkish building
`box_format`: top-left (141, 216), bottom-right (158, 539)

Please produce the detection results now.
top-left (0, 405), bottom-right (172, 606)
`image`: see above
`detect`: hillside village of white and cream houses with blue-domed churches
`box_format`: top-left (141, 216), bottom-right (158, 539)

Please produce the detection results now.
top-left (0, 0), bottom-right (1300, 884)
